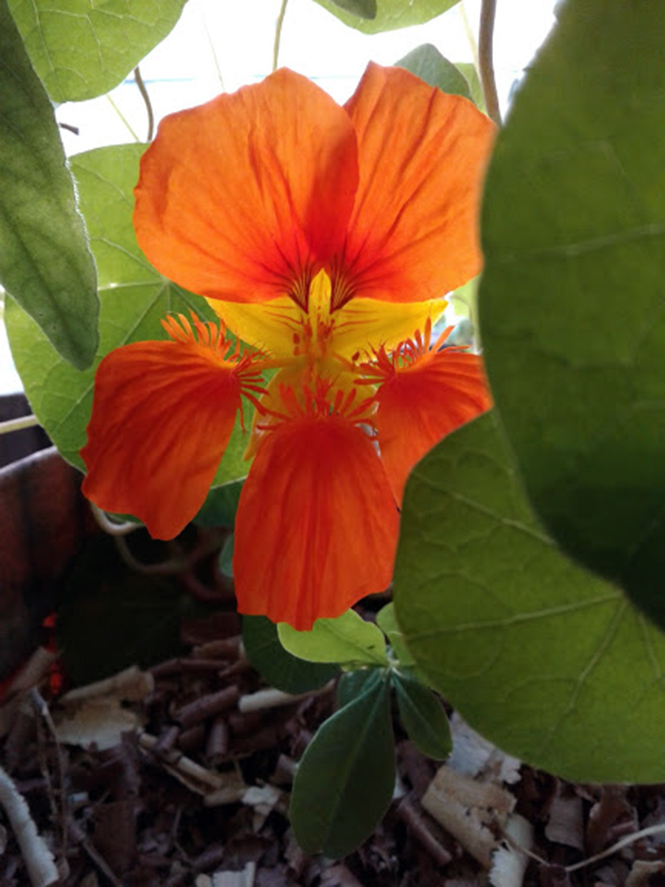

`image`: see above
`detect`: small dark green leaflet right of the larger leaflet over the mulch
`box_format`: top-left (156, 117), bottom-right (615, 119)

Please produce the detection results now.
top-left (393, 672), bottom-right (453, 761)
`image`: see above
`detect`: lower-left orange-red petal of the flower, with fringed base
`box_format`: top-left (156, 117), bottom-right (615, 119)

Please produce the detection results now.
top-left (81, 332), bottom-right (241, 539)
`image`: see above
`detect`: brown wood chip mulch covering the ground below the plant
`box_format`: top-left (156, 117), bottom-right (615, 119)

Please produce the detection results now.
top-left (0, 619), bottom-right (665, 887)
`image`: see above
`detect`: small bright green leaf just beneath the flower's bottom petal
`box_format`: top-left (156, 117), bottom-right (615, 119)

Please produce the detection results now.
top-left (278, 610), bottom-right (388, 665)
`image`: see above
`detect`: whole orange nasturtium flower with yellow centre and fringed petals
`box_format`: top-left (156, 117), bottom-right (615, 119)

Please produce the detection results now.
top-left (82, 64), bottom-right (493, 630)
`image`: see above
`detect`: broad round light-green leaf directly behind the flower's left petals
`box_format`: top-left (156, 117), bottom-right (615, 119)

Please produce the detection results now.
top-left (6, 145), bottom-right (252, 492)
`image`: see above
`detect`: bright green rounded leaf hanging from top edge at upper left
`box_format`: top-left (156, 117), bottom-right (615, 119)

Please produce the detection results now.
top-left (9, 0), bottom-right (185, 102)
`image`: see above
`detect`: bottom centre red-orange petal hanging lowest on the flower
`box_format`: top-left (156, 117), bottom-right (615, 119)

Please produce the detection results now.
top-left (233, 416), bottom-right (399, 631)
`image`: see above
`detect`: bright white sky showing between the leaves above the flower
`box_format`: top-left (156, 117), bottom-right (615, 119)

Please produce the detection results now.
top-left (0, 0), bottom-right (556, 394)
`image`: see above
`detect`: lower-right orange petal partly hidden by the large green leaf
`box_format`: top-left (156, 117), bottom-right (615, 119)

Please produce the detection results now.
top-left (375, 348), bottom-right (492, 503)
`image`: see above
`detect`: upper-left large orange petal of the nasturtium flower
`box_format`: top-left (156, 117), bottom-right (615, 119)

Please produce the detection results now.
top-left (134, 69), bottom-right (358, 302)
